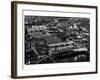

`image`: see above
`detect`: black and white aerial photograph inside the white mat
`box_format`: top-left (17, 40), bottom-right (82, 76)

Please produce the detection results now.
top-left (24, 15), bottom-right (90, 65)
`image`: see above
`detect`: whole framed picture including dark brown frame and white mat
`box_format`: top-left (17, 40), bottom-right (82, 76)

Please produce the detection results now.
top-left (11, 1), bottom-right (97, 78)
